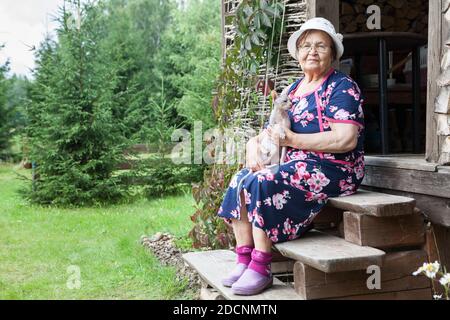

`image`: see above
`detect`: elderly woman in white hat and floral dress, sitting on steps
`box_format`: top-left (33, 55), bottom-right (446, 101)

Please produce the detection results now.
top-left (218, 18), bottom-right (364, 295)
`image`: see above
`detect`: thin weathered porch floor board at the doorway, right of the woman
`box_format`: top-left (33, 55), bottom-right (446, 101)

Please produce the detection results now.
top-left (364, 156), bottom-right (438, 172)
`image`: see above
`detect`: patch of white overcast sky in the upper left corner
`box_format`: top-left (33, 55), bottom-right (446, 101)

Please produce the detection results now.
top-left (0, 0), bottom-right (63, 77)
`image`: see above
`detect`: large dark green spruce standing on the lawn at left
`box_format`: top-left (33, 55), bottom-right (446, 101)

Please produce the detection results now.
top-left (27, 0), bottom-right (129, 205)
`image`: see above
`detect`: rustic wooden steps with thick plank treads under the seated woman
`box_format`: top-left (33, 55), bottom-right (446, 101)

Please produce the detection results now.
top-left (183, 190), bottom-right (432, 300)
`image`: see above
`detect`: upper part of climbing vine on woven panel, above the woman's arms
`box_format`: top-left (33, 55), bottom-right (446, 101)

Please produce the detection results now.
top-left (214, 0), bottom-right (284, 128)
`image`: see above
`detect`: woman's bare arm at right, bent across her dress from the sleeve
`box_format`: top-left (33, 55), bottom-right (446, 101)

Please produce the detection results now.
top-left (268, 122), bottom-right (358, 153)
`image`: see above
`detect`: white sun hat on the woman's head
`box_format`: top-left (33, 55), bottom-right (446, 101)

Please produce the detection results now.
top-left (288, 18), bottom-right (344, 60)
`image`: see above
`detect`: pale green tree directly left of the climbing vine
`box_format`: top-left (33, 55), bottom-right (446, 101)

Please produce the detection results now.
top-left (154, 0), bottom-right (221, 129)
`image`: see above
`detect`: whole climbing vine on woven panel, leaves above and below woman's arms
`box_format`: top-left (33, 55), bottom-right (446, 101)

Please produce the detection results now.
top-left (190, 0), bottom-right (285, 248)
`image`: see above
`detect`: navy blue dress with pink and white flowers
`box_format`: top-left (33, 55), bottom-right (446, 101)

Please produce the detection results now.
top-left (218, 69), bottom-right (364, 243)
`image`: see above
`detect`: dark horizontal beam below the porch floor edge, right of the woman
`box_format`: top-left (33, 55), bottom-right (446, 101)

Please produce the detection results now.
top-left (360, 166), bottom-right (450, 200)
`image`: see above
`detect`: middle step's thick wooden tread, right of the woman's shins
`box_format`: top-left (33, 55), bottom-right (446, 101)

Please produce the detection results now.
top-left (275, 230), bottom-right (384, 273)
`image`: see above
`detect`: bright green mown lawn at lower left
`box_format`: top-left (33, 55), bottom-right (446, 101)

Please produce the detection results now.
top-left (0, 165), bottom-right (199, 299)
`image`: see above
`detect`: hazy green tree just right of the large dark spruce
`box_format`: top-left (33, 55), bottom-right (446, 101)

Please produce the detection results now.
top-left (105, 0), bottom-right (176, 143)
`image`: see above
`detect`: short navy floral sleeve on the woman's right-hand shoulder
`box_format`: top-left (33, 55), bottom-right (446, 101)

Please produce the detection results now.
top-left (325, 78), bottom-right (364, 127)
